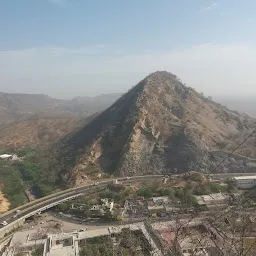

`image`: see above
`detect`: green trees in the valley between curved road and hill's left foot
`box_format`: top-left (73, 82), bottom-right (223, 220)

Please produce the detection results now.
top-left (0, 147), bottom-right (56, 208)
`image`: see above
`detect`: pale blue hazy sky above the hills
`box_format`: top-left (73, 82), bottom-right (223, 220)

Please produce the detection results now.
top-left (0, 0), bottom-right (256, 98)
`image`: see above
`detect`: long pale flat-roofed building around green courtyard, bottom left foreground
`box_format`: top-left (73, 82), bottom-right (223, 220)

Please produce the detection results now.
top-left (1, 222), bottom-right (159, 256)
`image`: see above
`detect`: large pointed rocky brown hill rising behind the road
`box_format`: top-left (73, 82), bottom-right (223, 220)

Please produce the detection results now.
top-left (53, 72), bottom-right (256, 183)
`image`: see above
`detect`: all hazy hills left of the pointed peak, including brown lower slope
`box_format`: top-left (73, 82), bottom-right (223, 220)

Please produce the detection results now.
top-left (0, 93), bottom-right (120, 148)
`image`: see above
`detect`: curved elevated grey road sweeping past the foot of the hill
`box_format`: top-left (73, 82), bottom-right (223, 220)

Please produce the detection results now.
top-left (0, 173), bottom-right (255, 236)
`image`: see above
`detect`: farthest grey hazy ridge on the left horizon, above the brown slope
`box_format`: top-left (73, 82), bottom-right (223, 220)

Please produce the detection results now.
top-left (0, 92), bottom-right (120, 124)
